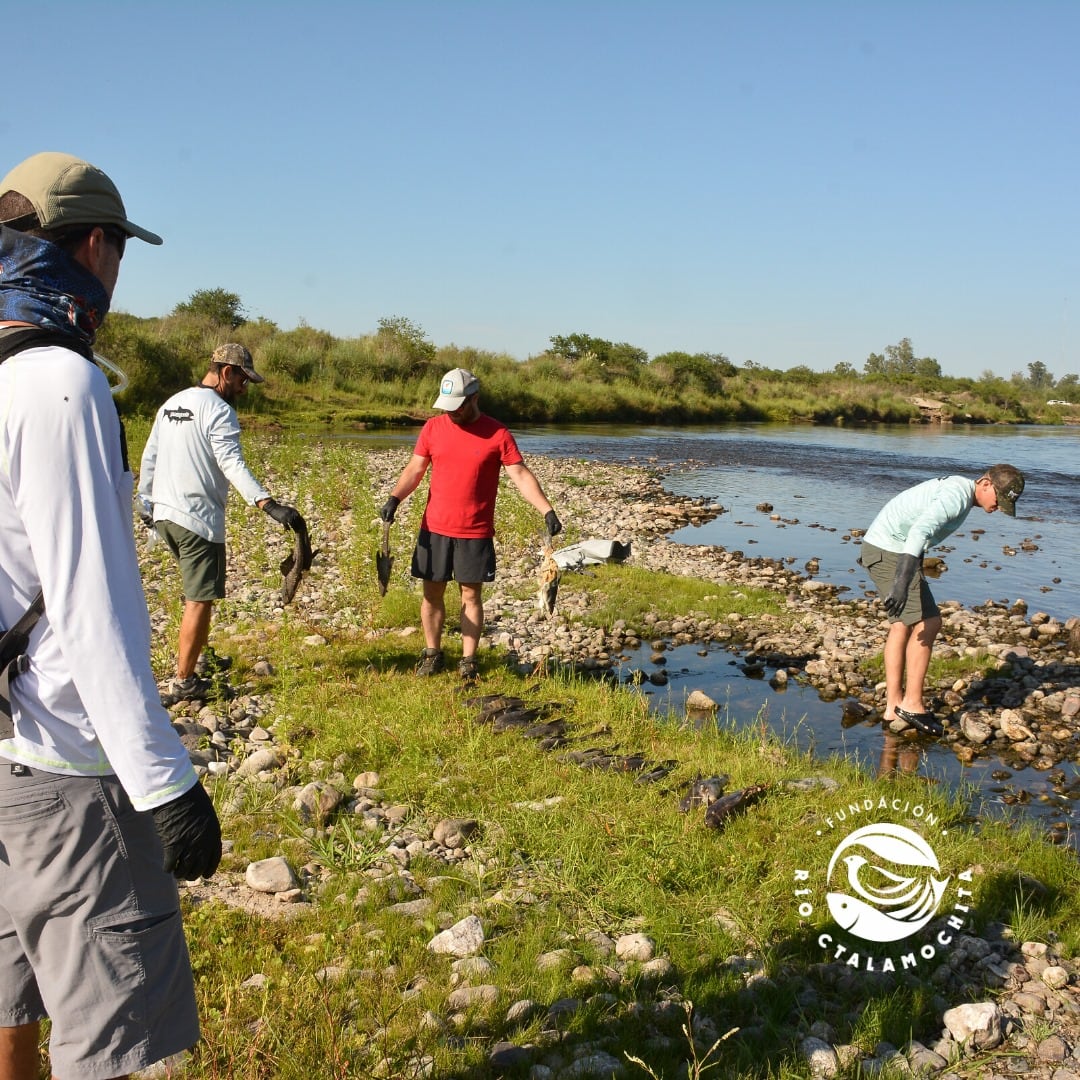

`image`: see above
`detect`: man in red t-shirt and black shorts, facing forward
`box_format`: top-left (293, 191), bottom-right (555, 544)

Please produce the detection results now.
top-left (379, 367), bottom-right (563, 681)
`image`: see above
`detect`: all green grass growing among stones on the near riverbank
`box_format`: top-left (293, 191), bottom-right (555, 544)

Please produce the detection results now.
top-left (113, 424), bottom-right (1080, 1080)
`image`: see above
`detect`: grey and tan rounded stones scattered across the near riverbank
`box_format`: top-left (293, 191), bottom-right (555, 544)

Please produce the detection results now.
top-left (143, 451), bottom-right (1080, 1080)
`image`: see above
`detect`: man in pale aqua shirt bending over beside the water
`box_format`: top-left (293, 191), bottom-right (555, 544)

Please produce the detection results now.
top-left (859, 464), bottom-right (1024, 735)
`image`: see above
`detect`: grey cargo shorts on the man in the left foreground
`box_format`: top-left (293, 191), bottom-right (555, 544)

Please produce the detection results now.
top-left (0, 758), bottom-right (199, 1080)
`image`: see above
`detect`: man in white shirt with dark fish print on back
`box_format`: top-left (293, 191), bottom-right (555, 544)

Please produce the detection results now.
top-left (138, 343), bottom-right (306, 701)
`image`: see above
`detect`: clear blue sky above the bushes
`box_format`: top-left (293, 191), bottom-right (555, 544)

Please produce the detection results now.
top-left (6, 0), bottom-right (1080, 377)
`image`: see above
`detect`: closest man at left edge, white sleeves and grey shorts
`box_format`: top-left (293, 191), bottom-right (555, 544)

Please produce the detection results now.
top-left (0, 153), bottom-right (221, 1080)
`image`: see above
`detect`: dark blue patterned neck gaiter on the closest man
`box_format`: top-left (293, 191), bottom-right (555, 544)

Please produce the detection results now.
top-left (0, 226), bottom-right (109, 346)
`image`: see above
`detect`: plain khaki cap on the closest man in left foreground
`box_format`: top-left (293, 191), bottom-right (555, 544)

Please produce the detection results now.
top-left (0, 151), bottom-right (161, 244)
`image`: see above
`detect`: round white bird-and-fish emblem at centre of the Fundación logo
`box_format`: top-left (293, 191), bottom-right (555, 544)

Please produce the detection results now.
top-left (825, 822), bottom-right (950, 942)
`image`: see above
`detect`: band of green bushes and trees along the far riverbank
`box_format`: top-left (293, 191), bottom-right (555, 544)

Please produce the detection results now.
top-left (97, 288), bottom-right (1080, 426)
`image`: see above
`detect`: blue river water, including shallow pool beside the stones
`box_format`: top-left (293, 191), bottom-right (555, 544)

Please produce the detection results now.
top-left (341, 424), bottom-right (1080, 846)
